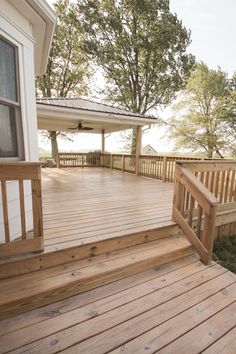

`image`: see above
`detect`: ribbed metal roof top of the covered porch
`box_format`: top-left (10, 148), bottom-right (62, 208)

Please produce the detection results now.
top-left (36, 97), bottom-right (155, 119)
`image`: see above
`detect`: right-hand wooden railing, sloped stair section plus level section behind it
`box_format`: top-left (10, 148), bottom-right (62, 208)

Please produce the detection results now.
top-left (173, 161), bottom-right (236, 264)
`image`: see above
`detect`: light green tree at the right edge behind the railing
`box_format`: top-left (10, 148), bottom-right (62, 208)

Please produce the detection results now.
top-left (167, 62), bottom-right (236, 158)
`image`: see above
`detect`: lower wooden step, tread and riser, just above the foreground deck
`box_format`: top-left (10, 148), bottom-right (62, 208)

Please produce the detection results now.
top-left (0, 236), bottom-right (193, 318)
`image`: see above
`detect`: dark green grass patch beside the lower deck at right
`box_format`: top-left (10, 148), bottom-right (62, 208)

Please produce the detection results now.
top-left (214, 236), bottom-right (236, 274)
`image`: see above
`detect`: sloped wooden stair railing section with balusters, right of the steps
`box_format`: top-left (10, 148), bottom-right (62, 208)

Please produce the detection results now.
top-left (172, 165), bottom-right (219, 264)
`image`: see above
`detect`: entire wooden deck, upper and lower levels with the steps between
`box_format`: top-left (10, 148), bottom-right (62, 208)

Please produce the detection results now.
top-left (0, 168), bottom-right (236, 354)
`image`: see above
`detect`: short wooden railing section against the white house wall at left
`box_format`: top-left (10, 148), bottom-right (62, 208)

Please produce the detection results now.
top-left (0, 162), bottom-right (43, 256)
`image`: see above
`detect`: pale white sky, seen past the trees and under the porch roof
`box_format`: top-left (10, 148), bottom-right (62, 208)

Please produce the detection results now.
top-left (40, 0), bottom-right (236, 153)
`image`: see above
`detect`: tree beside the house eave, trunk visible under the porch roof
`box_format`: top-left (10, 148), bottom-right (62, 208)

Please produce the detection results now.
top-left (36, 0), bottom-right (91, 160)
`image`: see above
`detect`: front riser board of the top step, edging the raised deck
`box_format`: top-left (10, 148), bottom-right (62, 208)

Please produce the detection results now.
top-left (0, 222), bottom-right (179, 279)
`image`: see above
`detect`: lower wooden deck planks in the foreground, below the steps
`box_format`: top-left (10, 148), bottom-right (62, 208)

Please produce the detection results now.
top-left (0, 255), bottom-right (236, 354)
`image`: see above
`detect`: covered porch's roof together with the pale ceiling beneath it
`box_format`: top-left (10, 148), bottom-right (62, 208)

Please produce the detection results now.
top-left (37, 99), bottom-right (157, 133)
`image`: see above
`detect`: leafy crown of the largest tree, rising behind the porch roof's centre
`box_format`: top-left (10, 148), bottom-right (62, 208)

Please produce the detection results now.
top-left (77, 0), bottom-right (194, 152)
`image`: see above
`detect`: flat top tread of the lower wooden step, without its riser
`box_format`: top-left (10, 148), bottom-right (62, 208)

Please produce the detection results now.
top-left (0, 236), bottom-right (191, 306)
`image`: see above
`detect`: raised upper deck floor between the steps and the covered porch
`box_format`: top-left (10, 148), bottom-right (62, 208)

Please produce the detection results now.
top-left (42, 168), bottom-right (173, 253)
